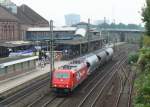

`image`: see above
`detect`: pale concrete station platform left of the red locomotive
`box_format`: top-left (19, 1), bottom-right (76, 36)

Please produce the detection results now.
top-left (0, 61), bottom-right (69, 96)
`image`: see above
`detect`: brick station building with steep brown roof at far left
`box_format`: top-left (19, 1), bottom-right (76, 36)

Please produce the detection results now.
top-left (0, 0), bottom-right (49, 41)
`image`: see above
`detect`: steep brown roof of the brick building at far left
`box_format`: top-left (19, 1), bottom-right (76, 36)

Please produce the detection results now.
top-left (0, 5), bottom-right (49, 27)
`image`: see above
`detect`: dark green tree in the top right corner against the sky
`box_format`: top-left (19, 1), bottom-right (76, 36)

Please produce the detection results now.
top-left (142, 0), bottom-right (150, 36)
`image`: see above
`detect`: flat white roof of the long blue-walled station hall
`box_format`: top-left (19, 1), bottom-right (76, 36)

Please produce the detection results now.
top-left (27, 27), bottom-right (76, 31)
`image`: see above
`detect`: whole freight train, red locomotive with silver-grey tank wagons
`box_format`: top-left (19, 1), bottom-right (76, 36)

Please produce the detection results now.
top-left (51, 48), bottom-right (113, 93)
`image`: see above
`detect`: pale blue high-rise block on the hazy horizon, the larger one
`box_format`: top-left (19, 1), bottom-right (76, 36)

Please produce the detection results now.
top-left (65, 14), bottom-right (80, 26)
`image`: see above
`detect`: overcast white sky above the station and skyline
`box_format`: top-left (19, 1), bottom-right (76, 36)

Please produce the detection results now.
top-left (12, 0), bottom-right (145, 26)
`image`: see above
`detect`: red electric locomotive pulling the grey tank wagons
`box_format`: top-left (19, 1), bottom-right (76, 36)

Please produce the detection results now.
top-left (52, 60), bottom-right (88, 92)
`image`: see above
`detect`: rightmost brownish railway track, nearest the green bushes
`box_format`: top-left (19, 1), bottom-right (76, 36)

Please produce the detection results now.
top-left (96, 43), bottom-right (138, 107)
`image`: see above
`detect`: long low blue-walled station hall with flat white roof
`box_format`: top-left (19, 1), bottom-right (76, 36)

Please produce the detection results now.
top-left (26, 27), bottom-right (76, 41)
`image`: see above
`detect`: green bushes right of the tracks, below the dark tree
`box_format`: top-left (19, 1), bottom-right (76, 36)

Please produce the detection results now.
top-left (134, 47), bottom-right (150, 107)
